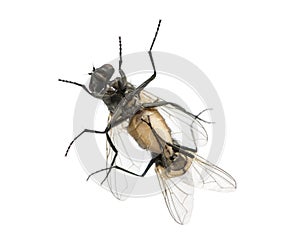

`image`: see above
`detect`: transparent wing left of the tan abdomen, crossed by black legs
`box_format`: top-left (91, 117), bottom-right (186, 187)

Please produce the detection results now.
top-left (105, 115), bottom-right (151, 200)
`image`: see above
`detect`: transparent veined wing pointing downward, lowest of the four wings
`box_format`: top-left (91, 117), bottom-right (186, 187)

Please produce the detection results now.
top-left (155, 166), bottom-right (194, 224)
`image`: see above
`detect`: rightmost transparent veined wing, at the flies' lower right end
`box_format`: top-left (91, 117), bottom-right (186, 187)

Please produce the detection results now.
top-left (190, 156), bottom-right (236, 191)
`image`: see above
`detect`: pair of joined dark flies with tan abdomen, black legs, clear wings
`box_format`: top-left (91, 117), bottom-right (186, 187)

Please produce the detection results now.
top-left (59, 20), bottom-right (236, 224)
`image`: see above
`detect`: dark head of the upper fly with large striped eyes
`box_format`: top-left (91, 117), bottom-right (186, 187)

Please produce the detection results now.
top-left (89, 64), bottom-right (115, 98)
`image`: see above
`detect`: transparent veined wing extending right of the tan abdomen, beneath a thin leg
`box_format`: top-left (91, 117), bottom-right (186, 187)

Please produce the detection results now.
top-left (140, 90), bottom-right (208, 150)
